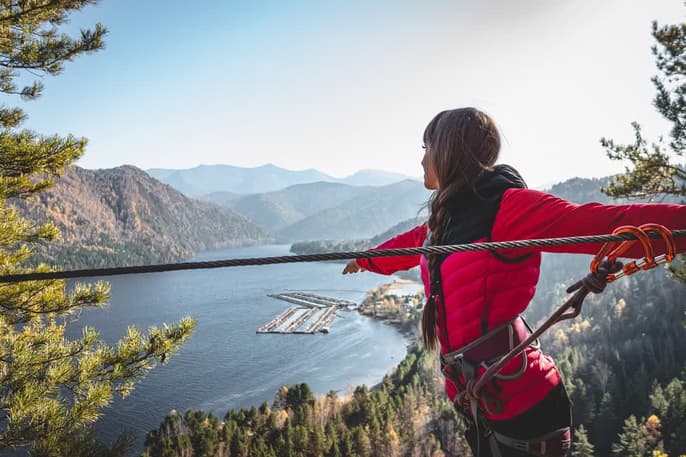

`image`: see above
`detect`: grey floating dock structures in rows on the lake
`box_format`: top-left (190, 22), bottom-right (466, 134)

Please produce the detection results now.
top-left (257, 292), bottom-right (358, 334)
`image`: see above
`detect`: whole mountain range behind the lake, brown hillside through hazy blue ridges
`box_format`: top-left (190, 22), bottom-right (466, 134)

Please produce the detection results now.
top-left (14, 166), bottom-right (672, 267)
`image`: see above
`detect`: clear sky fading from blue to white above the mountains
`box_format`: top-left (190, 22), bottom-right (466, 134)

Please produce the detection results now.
top-left (14, 0), bottom-right (686, 187)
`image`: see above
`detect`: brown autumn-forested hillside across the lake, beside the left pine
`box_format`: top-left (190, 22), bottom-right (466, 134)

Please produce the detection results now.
top-left (14, 166), bottom-right (269, 267)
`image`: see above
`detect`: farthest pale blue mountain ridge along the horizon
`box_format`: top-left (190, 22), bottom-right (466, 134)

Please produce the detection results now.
top-left (146, 164), bottom-right (410, 197)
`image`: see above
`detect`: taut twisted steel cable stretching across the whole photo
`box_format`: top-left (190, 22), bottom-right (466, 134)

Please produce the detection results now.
top-left (0, 230), bottom-right (686, 283)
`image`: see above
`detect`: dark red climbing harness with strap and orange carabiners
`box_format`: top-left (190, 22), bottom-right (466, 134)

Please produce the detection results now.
top-left (432, 224), bottom-right (676, 457)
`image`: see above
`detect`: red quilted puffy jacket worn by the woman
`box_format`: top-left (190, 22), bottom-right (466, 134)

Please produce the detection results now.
top-left (357, 188), bottom-right (686, 420)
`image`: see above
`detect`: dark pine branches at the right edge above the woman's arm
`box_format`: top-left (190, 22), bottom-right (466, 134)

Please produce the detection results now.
top-left (600, 7), bottom-right (686, 282)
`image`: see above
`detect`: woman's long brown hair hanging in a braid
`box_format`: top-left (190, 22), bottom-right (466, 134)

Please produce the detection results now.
top-left (422, 108), bottom-right (500, 350)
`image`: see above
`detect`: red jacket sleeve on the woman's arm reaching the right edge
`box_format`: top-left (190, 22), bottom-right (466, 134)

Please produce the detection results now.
top-left (491, 189), bottom-right (686, 258)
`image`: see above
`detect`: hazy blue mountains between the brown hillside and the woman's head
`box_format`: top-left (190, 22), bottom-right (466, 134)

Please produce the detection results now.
top-left (150, 165), bottom-right (430, 242)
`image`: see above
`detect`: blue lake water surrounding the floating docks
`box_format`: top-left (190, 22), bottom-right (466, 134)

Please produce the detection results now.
top-left (64, 245), bottom-right (406, 451)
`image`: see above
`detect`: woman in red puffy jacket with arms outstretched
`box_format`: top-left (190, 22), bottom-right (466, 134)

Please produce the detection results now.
top-left (343, 108), bottom-right (686, 457)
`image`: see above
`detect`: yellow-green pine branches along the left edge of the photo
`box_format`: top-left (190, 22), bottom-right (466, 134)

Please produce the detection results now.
top-left (0, 0), bottom-right (194, 455)
